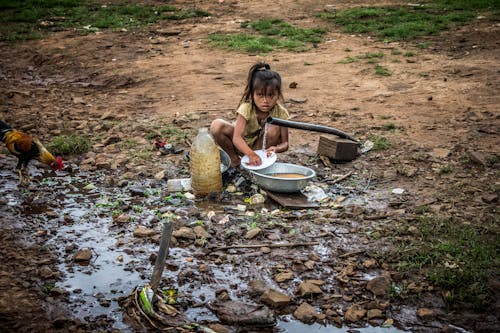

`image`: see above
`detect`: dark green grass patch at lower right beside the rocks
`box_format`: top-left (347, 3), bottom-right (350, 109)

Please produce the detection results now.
top-left (391, 214), bottom-right (500, 310)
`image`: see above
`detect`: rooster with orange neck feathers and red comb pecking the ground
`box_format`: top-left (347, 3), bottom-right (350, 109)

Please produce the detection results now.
top-left (0, 120), bottom-right (64, 183)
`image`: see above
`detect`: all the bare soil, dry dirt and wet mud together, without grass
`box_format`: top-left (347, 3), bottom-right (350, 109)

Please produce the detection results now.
top-left (0, 0), bottom-right (500, 332)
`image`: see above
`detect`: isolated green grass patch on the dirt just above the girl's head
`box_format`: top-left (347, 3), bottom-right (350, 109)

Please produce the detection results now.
top-left (208, 19), bottom-right (326, 54)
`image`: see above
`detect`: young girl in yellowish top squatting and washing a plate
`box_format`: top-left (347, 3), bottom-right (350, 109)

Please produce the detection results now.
top-left (210, 62), bottom-right (289, 167)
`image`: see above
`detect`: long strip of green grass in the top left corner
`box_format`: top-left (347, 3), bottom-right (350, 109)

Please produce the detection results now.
top-left (0, 0), bottom-right (210, 41)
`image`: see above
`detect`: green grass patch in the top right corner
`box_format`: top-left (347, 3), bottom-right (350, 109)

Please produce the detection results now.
top-left (317, 0), bottom-right (500, 41)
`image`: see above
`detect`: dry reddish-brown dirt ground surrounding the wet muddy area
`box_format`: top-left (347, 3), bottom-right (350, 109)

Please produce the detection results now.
top-left (0, 0), bottom-right (500, 332)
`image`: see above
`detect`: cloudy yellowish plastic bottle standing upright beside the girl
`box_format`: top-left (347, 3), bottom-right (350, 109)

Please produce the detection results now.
top-left (189, 127), bottom-right (222, 197)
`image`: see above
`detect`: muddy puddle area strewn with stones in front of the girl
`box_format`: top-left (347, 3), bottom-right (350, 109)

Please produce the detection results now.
top-left (1, 160), bottom-right (414, 333)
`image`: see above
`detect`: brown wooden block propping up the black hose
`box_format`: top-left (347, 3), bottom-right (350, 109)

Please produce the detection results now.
top-left (318, 135), bottom-right (359, 161)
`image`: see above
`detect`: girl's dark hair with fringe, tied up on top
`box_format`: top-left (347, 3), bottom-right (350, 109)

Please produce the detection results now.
top-left (240, 62), bottom-right (283, 104)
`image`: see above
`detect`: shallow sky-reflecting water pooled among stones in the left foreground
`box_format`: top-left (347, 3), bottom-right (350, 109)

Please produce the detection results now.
top-left (3, 165), bottom-right (410, 333)
